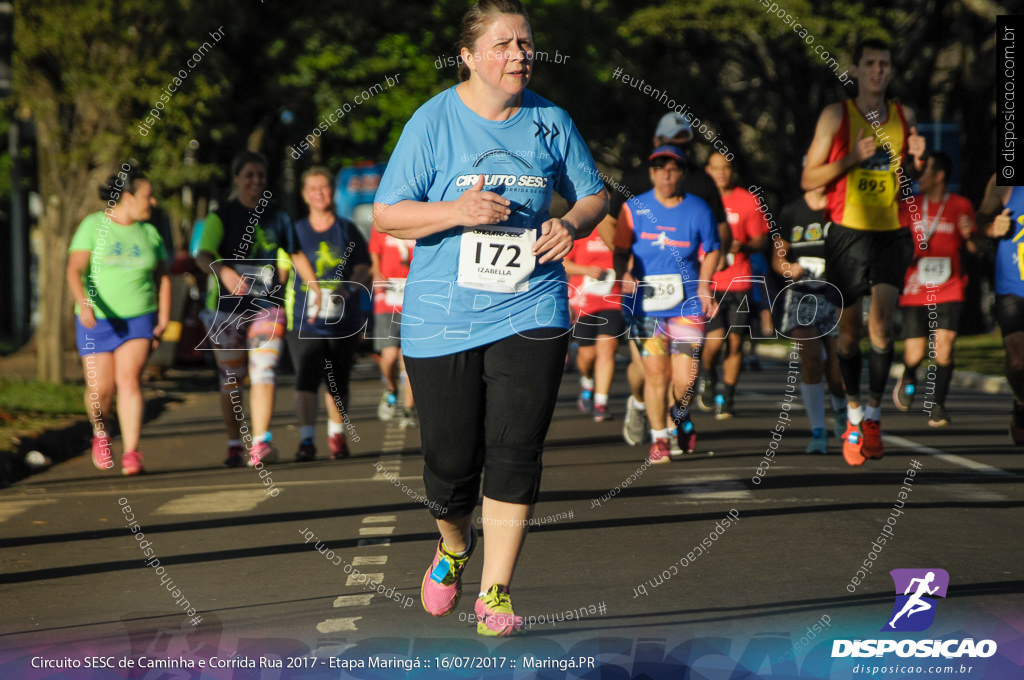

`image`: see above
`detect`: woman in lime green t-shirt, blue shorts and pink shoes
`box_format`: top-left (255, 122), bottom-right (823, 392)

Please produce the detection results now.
top-left (68, 168), bottom-right (171, 474)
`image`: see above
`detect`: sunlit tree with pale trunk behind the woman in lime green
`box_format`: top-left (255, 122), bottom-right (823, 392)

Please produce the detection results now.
top-left (14, 0), bottom-right (228, 382)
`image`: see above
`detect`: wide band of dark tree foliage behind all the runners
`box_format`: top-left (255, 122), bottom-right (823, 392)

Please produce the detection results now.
top-left (15, 0), bottom-right (998, 379)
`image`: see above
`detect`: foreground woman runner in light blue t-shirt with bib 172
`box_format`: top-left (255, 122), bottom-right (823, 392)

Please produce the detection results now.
top-left (374, 0), bottom-right (607, 636)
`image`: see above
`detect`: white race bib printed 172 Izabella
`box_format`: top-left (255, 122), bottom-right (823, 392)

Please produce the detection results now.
top-left (457, 225), bottom-right (537, 293)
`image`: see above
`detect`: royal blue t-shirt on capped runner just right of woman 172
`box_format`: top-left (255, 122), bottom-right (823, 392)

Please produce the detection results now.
top-left (623, 189), bottom-right (721, 317)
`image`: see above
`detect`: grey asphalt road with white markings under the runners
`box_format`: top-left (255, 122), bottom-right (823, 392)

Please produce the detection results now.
top-left (0, 350), bottom-right (1024, 680)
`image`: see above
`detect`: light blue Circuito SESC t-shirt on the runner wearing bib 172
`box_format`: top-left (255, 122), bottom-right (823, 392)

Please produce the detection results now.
top-left (376, 87), bottom-right (603, 356)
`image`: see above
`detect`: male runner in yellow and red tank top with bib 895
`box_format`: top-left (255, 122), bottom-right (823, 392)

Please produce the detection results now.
top-left (801, 40), bottom-right (925, 465)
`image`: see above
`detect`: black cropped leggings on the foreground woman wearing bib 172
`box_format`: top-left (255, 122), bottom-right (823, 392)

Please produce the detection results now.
top-left (406, 329), bottom-right (568, 519)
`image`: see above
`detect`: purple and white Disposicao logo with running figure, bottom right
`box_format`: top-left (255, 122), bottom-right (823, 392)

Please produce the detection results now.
top-left (831, 568), bottom-right (997, 658)
